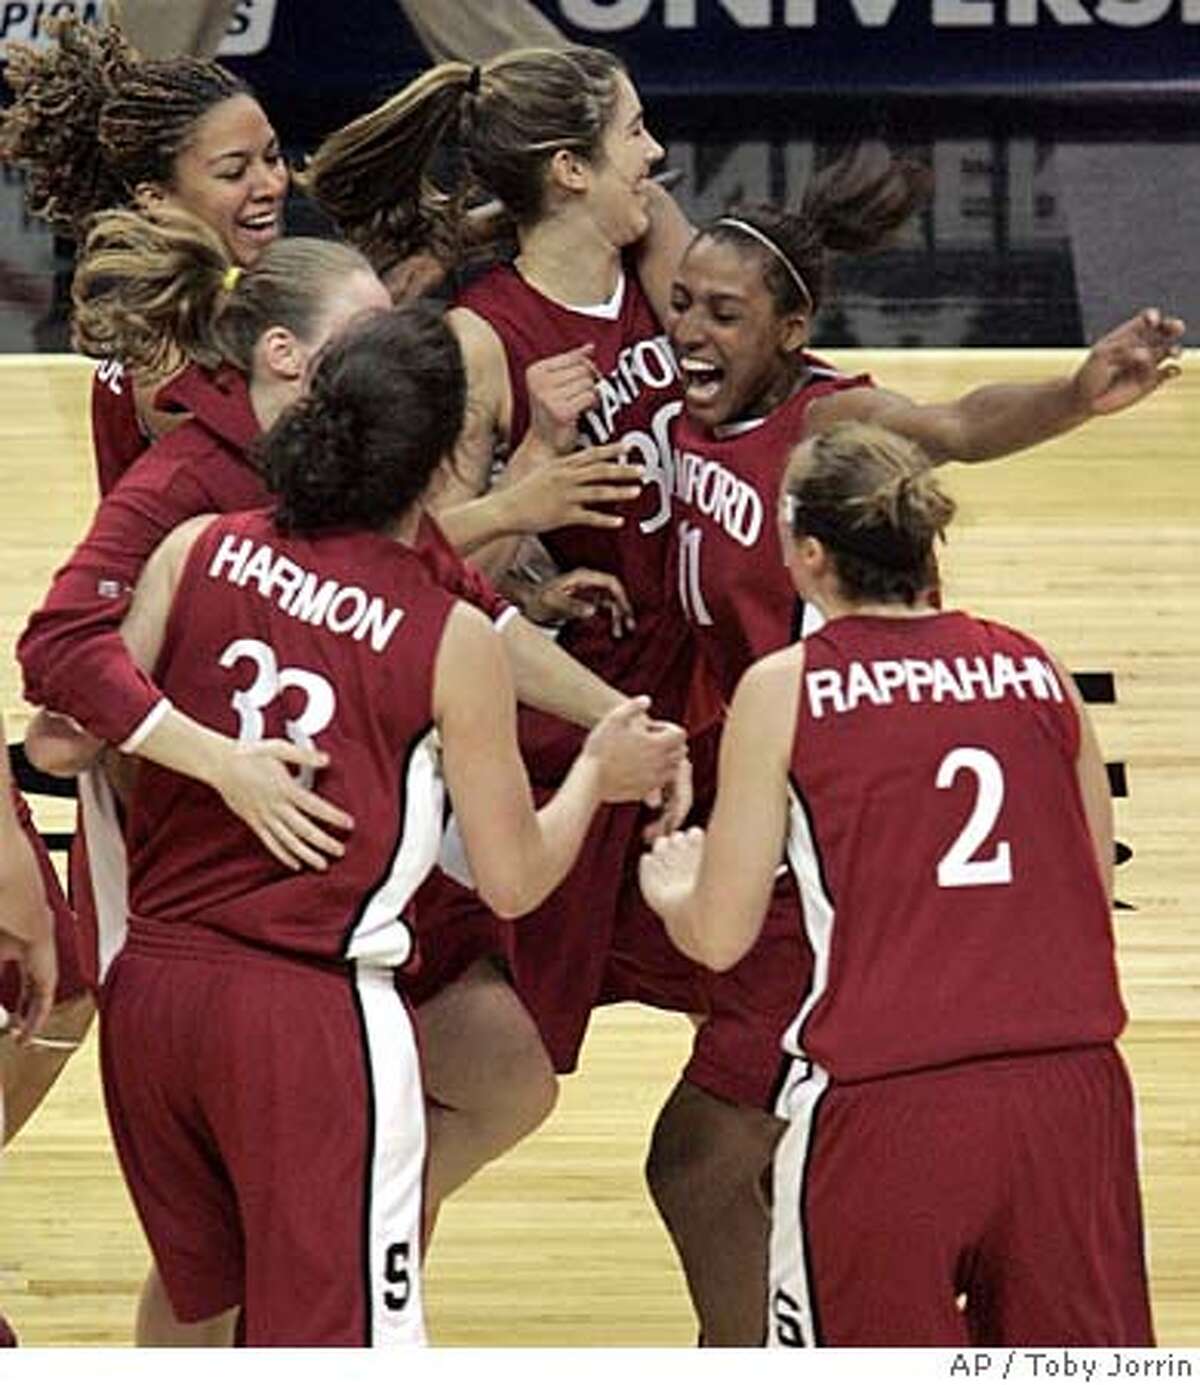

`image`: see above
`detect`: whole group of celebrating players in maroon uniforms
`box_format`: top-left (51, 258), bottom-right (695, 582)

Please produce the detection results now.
top-left (0, 21), bottom-right (1183, 1346)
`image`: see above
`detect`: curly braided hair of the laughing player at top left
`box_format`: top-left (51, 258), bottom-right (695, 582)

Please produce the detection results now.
top-left (0, 18), bottom-right (252, 234)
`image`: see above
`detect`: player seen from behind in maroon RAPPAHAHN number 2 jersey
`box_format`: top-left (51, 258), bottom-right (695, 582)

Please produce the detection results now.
top-left (642, 422), bottom-right (1153, 1346)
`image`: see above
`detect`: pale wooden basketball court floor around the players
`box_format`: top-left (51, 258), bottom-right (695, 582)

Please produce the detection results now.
top-left (0, 350), bottom-right (1200, 1346)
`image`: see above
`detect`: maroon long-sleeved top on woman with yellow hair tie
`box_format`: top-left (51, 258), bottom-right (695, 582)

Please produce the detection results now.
top-left (17, 367), bottom-right (511, 745)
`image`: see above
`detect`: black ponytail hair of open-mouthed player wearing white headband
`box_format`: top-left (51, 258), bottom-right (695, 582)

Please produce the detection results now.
top-left (697, 143), bottom-right (931, 317)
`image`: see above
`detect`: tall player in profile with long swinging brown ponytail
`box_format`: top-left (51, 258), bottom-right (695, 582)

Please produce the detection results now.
top-left (301, 48), bottom-right (698, 1124)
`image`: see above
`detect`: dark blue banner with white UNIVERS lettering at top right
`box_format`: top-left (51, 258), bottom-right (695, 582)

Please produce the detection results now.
top-left (538, 0), bottom-right (1200, 94)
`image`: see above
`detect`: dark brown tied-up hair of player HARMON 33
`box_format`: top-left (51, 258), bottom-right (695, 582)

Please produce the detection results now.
top-left (259, 303), bottom-right (467, 533)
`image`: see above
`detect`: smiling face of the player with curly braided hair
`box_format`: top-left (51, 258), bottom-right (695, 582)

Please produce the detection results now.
top-left (155, 96), bottom-right (288, 267)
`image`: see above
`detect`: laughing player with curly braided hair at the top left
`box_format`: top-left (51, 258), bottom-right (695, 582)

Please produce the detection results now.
top-left (0, 18), bottom-right (288, 494)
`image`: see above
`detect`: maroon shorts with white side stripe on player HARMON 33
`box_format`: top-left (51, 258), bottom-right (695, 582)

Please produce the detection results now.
top-left (100, 924), bottom-right (425, 1346)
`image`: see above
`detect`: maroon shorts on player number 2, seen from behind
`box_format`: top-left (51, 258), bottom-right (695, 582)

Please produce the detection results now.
top-left (769, 1046), bottom-right (1153, 1348)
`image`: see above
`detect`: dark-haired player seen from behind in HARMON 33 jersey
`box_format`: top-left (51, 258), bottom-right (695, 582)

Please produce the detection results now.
top-left (93, 300), bottom-right (683, 1346)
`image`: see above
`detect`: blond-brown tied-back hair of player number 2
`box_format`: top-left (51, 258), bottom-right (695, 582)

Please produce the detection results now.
top-left (784, 422), bottom-right (955, 605)
